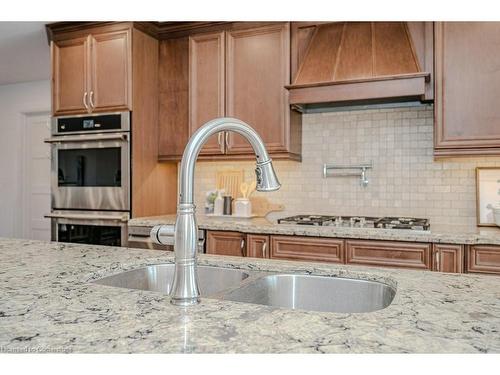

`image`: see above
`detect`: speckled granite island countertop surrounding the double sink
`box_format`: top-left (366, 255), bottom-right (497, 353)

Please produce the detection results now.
top-left (0, 239), bottom-right (500, 353)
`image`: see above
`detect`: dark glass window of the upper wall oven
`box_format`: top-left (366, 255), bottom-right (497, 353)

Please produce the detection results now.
top-left (57, 147), bottom-right (122, 186)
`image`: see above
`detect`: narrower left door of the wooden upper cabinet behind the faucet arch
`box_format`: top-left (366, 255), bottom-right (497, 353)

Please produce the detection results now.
top-left (189, 32), bottom-right (225, 155)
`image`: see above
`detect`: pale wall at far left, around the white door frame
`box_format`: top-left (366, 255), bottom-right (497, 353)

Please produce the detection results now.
top-left (0, 80), bottom-right (50, 237)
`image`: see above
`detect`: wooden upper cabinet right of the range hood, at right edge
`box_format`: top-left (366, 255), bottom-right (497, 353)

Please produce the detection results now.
top-left (434, 22), bottom-right (500, 156)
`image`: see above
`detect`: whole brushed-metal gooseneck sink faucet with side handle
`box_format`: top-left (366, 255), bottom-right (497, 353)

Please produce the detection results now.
top-left (151, 117), bottom-right (281, 306)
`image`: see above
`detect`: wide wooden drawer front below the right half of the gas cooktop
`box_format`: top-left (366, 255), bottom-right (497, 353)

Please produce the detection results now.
top-left (346, 241), bottom-right (431, 269)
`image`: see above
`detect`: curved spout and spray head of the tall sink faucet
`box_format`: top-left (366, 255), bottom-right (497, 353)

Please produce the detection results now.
top-left (179, 117), bottom-right (281, 204)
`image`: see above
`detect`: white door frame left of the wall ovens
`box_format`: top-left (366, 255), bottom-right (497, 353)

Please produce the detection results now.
top-left (16, 111), bottom-right (50, 238)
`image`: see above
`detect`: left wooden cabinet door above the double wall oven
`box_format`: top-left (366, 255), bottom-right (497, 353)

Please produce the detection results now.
top-left (51, 36), bottom-right (90, 115)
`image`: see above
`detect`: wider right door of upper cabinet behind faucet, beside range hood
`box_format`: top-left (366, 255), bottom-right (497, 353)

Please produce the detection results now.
top-left (226, 24), bottom-right (290, 154)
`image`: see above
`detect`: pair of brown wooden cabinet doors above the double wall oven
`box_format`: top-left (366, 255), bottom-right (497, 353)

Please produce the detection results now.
top-left (51, 29), bottom-right (132, 115)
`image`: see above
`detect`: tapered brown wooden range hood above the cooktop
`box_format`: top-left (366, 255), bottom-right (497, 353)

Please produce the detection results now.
top-left (286, 22), bottom-right (431, 109)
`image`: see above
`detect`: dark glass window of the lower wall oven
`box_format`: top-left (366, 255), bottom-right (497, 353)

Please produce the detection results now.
top-left (57, 224), bottom-right (121, 246)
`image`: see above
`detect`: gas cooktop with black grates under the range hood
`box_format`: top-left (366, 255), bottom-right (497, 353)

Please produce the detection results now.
top-left (278, 215), bottom-right (430, 230)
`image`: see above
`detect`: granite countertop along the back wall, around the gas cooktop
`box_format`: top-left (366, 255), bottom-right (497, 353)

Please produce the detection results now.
top-left (129, 215), bottom-right (500, 245)
